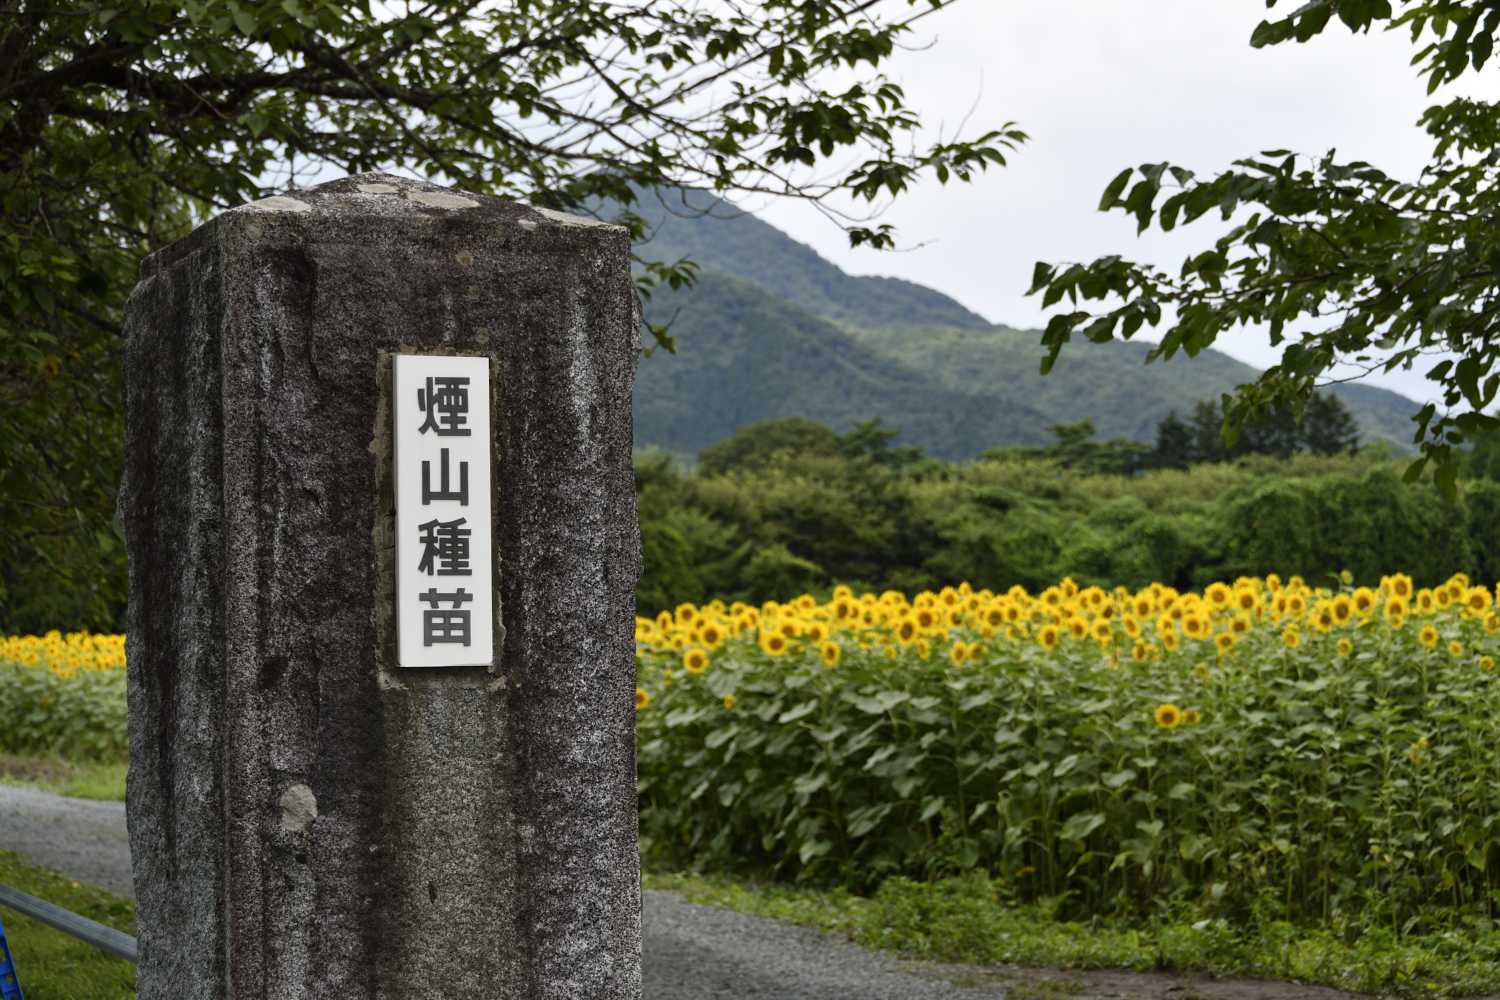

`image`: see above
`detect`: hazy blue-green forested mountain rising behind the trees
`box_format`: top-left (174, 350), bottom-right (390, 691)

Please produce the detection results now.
top-left (636, 192), bottom-right (1416, 459)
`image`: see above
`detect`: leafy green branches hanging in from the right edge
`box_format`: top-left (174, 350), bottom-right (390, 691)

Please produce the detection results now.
top-left (1032, 0), bottom-right (1500, 495)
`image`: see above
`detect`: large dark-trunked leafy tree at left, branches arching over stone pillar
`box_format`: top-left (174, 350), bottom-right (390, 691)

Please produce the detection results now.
top-left (0, 0), bottom-right (1025, 627)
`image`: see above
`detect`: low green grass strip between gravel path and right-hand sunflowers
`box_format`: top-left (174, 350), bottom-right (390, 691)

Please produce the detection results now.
top-left (644, 873), bottom-right (1500, 1000)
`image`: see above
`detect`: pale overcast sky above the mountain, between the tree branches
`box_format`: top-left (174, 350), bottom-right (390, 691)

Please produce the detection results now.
top-left (744, 0), bottom-right (1494, 399)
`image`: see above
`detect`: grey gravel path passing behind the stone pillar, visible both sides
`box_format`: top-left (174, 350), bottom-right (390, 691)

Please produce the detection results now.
top-left (0, 786), bottom-right (1005, 1000)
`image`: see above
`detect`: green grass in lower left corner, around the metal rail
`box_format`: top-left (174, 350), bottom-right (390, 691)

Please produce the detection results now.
top-left (0, 850), bottom-right (135, 1000)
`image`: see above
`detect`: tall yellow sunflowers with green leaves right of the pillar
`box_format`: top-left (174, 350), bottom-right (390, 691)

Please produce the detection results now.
top-left (636, 574), bottom-right (1500, 934)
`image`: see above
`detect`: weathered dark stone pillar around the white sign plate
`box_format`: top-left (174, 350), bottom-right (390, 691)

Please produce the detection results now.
top-left (120, 174), bottom-right (641, 1000)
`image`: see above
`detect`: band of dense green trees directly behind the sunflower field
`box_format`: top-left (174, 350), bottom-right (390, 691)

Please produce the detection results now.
top-left (636, 406), bottom-right (1500, 615)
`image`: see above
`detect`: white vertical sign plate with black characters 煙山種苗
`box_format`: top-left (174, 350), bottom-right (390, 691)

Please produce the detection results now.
top-left (393, 354), bottom-right (495, 667)
